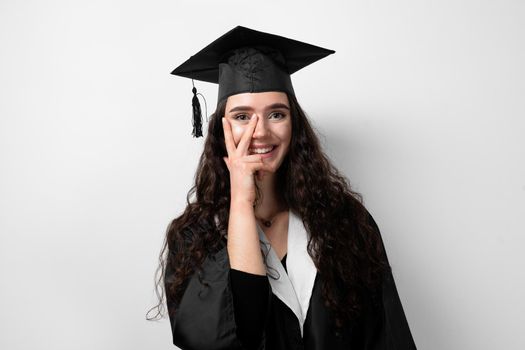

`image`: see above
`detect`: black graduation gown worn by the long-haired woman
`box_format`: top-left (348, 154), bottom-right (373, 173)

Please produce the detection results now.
top-left (166, 220), bottom-right (416, 350)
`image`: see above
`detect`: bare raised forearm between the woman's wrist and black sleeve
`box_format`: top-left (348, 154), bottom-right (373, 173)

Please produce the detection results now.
top-left (228, 201), bottom-right (266, 275)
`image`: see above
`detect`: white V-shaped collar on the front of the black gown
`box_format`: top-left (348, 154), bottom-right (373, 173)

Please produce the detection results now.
top-left (257, 210), bottom-right (317, 336)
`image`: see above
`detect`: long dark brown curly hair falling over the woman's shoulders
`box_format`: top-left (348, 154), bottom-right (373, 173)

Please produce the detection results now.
top-left (147, 94), bottom-right (389, 328)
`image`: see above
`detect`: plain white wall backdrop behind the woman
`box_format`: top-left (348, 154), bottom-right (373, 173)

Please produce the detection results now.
top-left (0, 0), bottom-right (525, 350)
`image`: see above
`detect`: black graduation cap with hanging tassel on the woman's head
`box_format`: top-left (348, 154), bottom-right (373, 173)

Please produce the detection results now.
top-left (171, 26), bottom-right (335, 137)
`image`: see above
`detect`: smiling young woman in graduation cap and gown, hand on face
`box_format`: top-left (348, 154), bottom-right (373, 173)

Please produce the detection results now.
top-left (149, 27), bottom-right (415, 350)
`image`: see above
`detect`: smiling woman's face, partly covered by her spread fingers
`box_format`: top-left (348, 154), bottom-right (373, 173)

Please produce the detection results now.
top-left (224, 91), bottom-right (292, 172)
